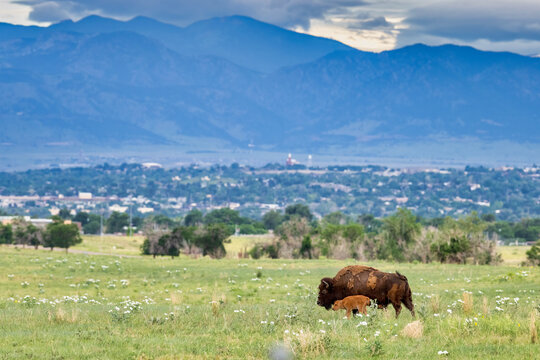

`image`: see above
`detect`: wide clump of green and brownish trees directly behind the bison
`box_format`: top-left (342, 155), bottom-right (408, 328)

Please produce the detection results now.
top-left (250, 205), bottom-right (506, 264)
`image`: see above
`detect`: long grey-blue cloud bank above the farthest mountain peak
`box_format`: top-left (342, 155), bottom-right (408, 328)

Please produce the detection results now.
top-left (17, 0), bottom-right (365, 29)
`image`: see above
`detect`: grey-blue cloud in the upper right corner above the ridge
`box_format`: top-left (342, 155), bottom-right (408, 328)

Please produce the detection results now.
top-left (402, 0), bottom-right (540, 42)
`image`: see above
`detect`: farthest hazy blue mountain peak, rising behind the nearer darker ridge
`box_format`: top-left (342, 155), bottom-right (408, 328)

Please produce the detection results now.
top-left (50, 15), bottom-right (351, 72)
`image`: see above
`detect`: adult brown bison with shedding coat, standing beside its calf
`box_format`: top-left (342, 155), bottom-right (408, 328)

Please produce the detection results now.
top-left (317, 265), bottom-right (415, 317)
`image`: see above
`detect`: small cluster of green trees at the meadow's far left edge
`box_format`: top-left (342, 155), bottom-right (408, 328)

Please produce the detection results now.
top-left (0, 216), bottom-right (82, 251)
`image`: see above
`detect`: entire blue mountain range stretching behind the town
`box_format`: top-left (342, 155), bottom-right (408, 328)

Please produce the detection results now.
top-left (0, 15), bottom-right (540, 163)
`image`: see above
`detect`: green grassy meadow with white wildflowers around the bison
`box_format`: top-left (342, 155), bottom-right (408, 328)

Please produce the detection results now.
top-left (0, 247), bottom-right (540, 359)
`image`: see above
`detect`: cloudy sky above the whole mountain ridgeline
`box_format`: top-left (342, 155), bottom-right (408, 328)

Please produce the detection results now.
top-left (0, 0), bottom-right (540, 55)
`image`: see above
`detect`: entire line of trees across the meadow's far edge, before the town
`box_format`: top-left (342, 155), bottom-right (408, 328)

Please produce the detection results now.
top-left (0, 204), bottom-right (540, 264)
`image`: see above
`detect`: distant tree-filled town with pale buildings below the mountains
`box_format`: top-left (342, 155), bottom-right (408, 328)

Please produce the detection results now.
top-left (0, 158), bottom-right (540, 221)
